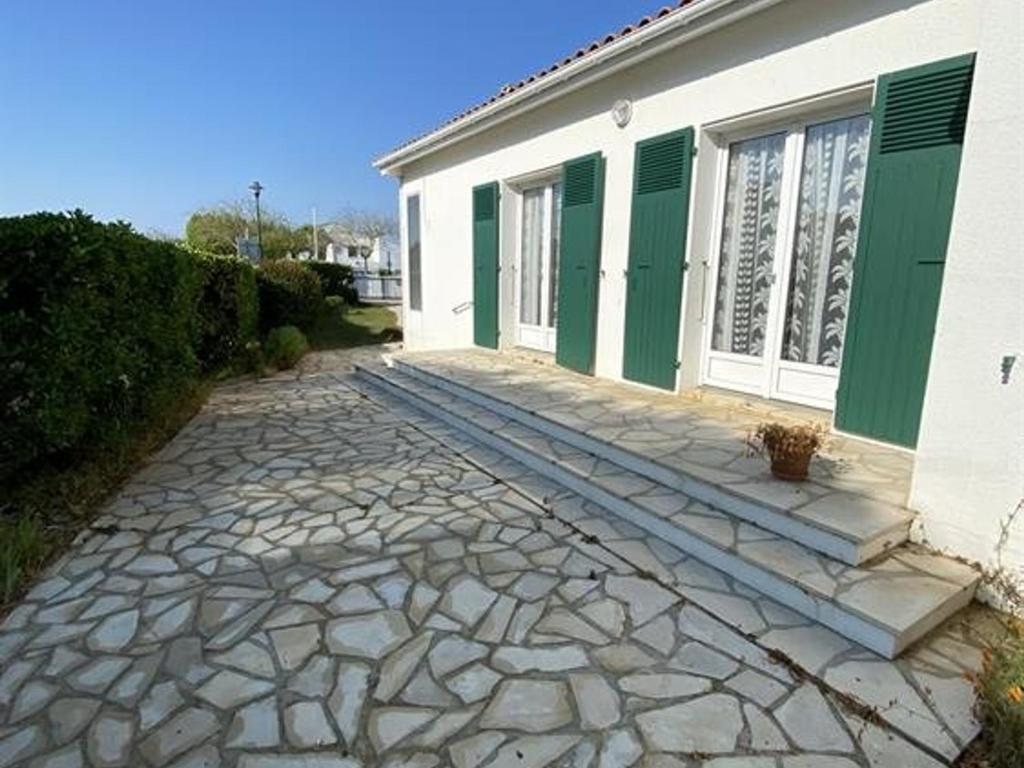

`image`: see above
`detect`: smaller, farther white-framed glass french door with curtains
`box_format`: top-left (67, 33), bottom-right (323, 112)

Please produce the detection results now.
top-left (516, 182), bottom-right (562, 352)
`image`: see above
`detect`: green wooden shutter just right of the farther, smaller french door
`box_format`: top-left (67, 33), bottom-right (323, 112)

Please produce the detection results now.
top-left (555, 153), bottom-right (604, 374)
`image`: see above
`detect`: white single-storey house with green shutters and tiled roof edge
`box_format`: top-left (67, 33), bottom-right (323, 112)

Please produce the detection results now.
top-left (376, 0), bottom-right (1024, 602)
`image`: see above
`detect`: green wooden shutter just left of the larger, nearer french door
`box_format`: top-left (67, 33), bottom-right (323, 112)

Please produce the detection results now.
top-left (623, 128), bottom-right (693, 389)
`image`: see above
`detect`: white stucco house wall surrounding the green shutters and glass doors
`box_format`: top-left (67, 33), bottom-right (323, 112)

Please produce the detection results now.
top-left (387, 0), bottom-right (1024, 589)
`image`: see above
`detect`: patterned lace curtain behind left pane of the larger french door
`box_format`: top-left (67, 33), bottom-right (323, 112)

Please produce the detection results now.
top-left (712, 133), bottom-right (785, 356)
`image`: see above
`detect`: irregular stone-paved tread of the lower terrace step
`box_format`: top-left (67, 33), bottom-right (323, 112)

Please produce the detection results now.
top-left (365, 365), bottom-right (978, 663)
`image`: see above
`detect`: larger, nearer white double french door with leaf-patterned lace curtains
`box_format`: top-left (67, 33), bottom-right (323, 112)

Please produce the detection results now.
top-left (703, 115), bottom-right (870, 410)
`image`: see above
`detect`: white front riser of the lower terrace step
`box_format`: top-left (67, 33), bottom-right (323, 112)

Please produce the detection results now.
top-left (356, 366), bottom-right (974, 658)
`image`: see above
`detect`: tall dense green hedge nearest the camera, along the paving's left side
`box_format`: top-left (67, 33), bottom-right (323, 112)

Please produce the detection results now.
top-left (0, 211), bottom-right (256, 485)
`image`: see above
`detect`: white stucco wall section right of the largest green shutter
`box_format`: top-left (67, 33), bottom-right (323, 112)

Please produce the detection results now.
top-left (910, 0), bottom-right (1024, 606)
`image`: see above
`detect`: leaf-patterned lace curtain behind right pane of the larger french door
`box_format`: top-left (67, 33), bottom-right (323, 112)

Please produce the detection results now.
top-left (782, 115), bottom-right (870, 368)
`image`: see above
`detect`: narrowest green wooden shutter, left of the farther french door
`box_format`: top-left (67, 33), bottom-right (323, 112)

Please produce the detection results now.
top-left (473, 182), bottom-right (498, 349)
